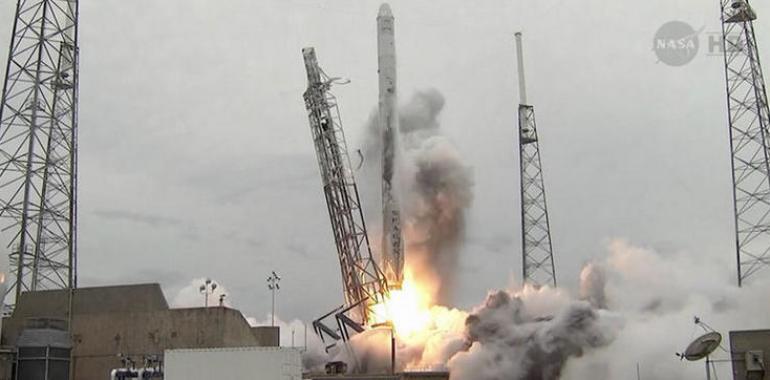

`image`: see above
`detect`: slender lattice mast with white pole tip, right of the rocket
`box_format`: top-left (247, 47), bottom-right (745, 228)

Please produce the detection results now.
top-left (516, 33), bottom-right (556, 287)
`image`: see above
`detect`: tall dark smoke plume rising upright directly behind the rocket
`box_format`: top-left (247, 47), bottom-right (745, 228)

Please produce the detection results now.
top-left (361, 89), bottom-right (473, 304)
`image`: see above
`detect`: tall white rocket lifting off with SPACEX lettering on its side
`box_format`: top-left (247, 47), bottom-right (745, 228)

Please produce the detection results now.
top-left (377, 3), bottom-right (404, 289)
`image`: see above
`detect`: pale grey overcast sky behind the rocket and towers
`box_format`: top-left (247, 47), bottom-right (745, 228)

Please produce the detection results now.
top-left (0, 0), bottom-right (770, 320)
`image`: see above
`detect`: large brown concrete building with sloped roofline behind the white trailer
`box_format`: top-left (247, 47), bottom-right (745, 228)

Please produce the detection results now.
top-left (0, 284), bottom-right (279, 380)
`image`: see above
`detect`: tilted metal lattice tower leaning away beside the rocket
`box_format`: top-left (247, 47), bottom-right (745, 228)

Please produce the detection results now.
top-left (302, 48), bottom-right (388, 325)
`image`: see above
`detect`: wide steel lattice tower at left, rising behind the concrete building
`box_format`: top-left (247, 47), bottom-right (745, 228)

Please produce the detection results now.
top-left (0, 0), bottom-right (78, 302)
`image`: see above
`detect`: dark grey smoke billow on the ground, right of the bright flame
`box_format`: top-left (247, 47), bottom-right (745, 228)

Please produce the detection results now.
top-left (448, 291), bottom-right (614, 380)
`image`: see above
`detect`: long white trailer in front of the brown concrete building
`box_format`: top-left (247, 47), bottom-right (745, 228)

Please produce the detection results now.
top-left (164, 347), bottom-right (302, 380)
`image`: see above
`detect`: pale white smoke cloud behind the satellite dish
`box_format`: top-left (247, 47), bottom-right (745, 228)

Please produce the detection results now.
top-left (563, 240), bottom-right (770, 380)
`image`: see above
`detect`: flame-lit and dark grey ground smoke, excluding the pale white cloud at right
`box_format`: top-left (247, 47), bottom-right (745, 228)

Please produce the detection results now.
top-left (324, 278), bottom-right (620, 380)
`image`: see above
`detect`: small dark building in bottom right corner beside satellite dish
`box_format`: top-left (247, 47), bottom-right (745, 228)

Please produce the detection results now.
top-left (730, 330), bottom-right (770, 380)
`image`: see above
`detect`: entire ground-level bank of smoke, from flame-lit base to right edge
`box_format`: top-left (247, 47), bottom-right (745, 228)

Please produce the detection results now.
top-left (310, 240), bottom-right (770, 380)
